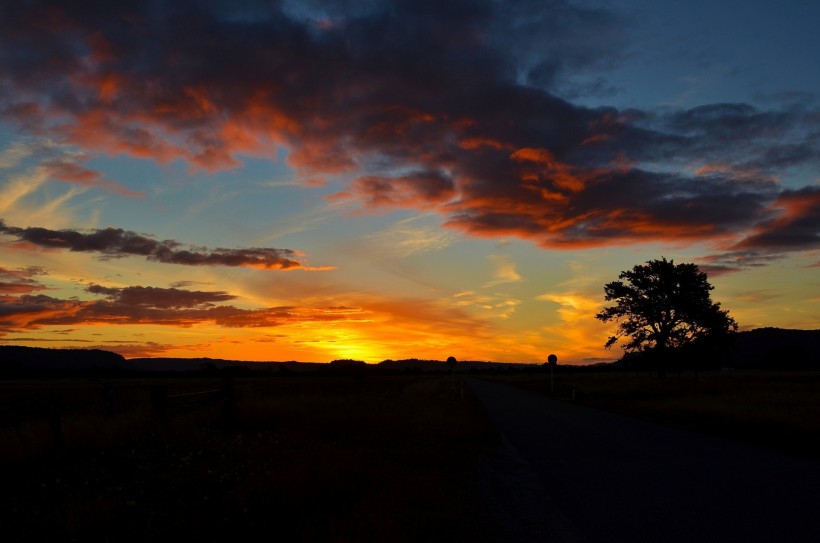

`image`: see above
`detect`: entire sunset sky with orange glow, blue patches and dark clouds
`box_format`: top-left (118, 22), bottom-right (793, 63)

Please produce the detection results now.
top-left (0, 0), bottom-right (820, 363)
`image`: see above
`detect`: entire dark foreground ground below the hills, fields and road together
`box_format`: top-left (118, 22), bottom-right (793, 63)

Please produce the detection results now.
top-left (0, 372), bottom-right (820, 543)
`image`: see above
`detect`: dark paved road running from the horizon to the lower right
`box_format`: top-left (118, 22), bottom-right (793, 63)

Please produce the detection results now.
top-left (470, 379), bottom-right (820, 543)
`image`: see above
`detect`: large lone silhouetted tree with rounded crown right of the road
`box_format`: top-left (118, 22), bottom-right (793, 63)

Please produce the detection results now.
top-left (595, 258), bottom-right (737, 371)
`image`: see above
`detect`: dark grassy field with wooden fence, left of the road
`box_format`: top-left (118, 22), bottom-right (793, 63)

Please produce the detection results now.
top-left (0, 375), bottom-right (498, 541)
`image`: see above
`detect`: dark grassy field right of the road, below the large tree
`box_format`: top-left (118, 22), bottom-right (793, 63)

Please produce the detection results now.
top-left (484, 371), bottom-right (820, 459)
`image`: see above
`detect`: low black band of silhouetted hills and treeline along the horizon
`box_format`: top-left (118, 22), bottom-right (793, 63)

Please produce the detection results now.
top-left (0, 328), bottom-right (820, 378)
